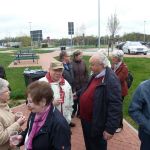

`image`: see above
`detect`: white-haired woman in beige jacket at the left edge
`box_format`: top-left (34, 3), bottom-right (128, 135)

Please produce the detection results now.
top-left (0, 78), bottom-right (25, 150)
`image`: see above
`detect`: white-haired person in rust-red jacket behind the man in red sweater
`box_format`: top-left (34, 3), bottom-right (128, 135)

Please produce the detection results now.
top-left (111, 50), bottom-right (128, 132)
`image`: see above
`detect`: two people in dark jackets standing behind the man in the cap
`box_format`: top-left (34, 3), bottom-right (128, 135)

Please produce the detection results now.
top-left (59, 50), bottom-right (89, 117)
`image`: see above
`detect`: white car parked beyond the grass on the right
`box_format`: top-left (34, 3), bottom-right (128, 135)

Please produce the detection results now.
top-left (122, 41), bottom-right (148, 55)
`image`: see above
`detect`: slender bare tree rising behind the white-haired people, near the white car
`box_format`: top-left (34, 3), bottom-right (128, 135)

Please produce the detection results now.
top-left (107, 13), bottom-right (120, 50)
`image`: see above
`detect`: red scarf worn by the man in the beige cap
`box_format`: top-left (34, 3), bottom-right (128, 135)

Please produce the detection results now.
top-left (46, 72), bottom-right (65, 113)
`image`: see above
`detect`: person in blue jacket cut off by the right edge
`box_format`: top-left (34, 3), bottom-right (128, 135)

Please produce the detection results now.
top-left (129, 80), bottom-right (150, 150)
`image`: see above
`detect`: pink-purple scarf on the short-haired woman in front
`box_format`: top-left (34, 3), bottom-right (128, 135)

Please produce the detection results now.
top-left (27, 105), bottom-right (51, 150)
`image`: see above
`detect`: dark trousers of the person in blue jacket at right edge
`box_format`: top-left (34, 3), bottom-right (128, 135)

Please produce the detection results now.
top-left (139, 129), bottom-right (150, 150)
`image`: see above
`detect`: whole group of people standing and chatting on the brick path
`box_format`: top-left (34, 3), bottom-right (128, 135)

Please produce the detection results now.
top-left (0, 50), bottom-right (150, 150)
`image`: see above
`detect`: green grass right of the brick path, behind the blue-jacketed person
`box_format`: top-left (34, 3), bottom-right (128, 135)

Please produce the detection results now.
top-left (123, 58), bottom-right (150, 127)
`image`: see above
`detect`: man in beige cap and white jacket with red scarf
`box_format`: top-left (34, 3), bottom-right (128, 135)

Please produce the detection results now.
top-left (39, 61), bottom-right (73, 124)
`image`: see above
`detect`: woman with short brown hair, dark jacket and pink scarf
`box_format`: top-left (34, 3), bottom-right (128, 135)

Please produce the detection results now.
top-left (11, 81), bottom-right (71, 150)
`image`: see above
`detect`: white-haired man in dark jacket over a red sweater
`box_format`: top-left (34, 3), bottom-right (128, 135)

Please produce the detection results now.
top-left (80, 52), bottom-right (122, 150)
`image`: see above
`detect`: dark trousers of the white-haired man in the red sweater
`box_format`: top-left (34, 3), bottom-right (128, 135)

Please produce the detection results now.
top-left (81, 119), bottom-right (107, 150)
